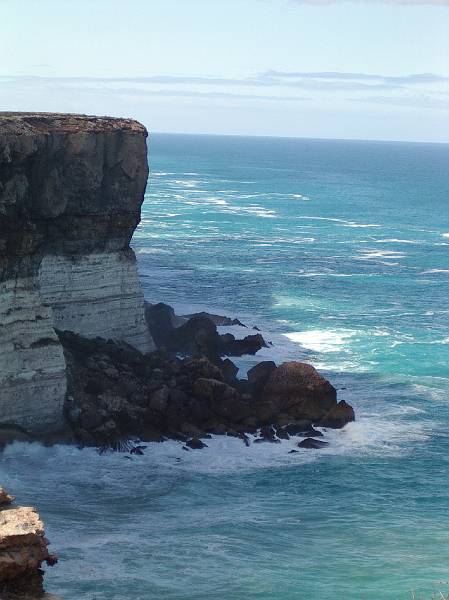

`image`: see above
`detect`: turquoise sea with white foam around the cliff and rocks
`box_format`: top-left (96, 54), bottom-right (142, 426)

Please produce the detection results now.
top-left (0, 135), bottom-right (449, 600)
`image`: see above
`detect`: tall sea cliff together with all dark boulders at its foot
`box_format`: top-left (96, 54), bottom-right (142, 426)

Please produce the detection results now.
top-left (0, 113), bottom-right (354, 448)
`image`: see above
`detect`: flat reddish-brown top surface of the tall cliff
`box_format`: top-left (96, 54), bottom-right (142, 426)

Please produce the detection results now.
top-left (0, 112), bottom-right (147, 135)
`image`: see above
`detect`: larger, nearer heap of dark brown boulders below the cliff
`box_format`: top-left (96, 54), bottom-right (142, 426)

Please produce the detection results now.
top-left (59, 332), bottom-right (354, 448)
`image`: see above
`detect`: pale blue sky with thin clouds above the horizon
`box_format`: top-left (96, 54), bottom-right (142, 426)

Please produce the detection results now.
top-left (0, 0), bottom-right (449, 142)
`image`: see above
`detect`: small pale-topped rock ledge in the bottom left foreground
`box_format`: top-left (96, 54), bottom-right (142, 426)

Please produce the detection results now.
top-left (0, 487), bottom-right (57, 599)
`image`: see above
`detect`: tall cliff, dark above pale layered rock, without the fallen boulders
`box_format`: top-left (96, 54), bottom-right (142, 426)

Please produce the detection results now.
top-left (0, 113), bottom-right (153, 432)
